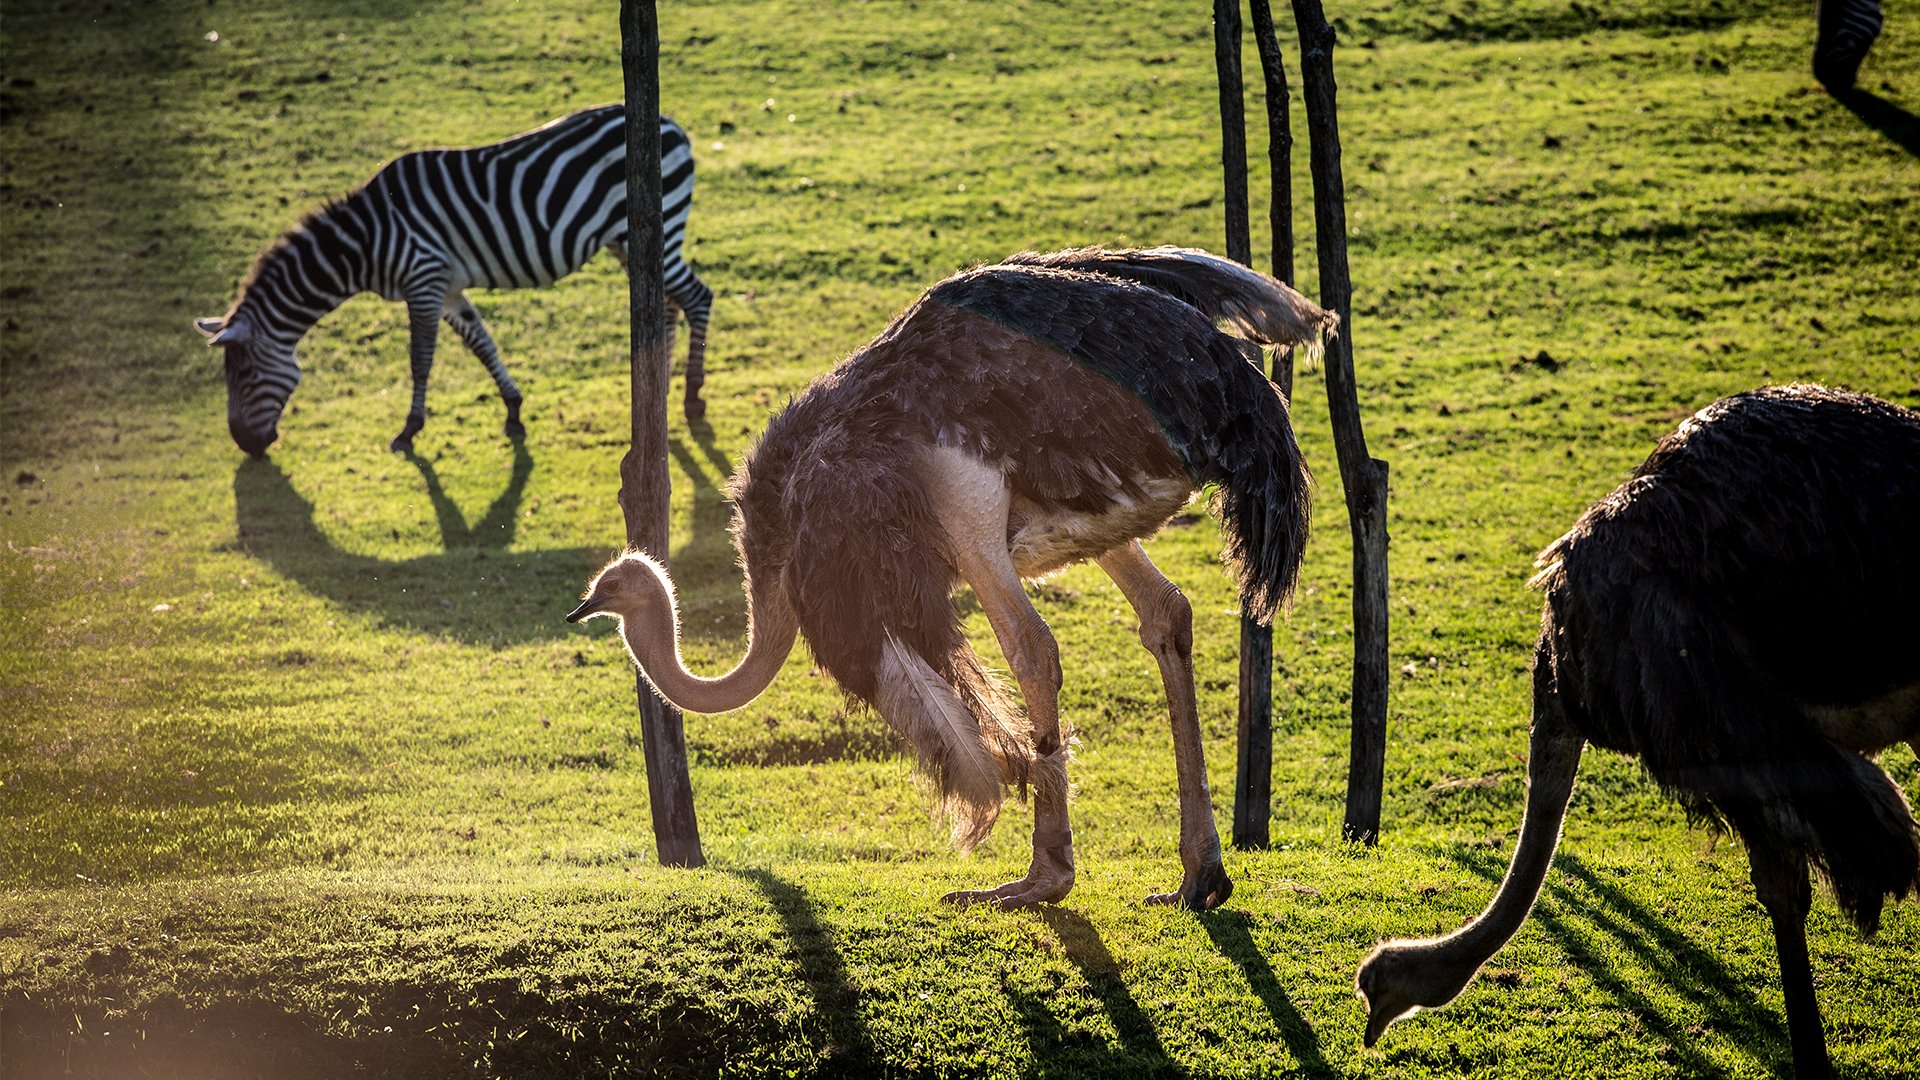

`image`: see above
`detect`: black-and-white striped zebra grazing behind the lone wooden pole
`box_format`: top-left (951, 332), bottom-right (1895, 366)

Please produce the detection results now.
top-left (194, 106), bottom-right (712, 457)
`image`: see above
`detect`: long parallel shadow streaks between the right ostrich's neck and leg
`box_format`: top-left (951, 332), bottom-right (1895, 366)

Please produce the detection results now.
top-left (1453, 851), bottom-right (1793, 1076)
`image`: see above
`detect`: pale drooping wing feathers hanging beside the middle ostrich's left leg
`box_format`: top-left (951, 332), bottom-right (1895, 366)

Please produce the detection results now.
top-left (876, 634), bottom-right (1006, 851)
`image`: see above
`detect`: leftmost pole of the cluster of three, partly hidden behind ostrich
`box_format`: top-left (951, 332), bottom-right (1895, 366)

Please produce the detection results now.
top-left (1213, 0), bottom-right (1273, 847)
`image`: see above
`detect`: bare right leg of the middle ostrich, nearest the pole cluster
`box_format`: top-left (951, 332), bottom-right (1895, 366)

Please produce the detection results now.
top-left (1098, 540), bottom-right (1233, 911)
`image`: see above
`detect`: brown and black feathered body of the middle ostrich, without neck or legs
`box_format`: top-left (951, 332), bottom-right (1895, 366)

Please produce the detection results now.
top-left (732, 250), bottom-right (1332, 842)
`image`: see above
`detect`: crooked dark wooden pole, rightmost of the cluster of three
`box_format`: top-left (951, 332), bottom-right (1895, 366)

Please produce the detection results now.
top-left (1292, 0), bottom-right (1388, 844)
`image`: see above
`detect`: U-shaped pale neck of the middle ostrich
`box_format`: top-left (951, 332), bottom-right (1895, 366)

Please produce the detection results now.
top-left (620, 568), bottom-right (799, 713)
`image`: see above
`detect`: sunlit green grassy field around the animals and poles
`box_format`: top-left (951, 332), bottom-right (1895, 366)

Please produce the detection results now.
top-left (0, 0), bottom-right (1920, 1078)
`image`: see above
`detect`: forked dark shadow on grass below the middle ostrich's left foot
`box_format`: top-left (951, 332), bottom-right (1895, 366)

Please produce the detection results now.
top-left (1006, 905), bottom-right (1185, 1076)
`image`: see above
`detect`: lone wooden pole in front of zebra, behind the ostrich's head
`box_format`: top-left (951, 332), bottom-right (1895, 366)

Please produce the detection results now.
top-left (620, 0), bottom-right (707, 867)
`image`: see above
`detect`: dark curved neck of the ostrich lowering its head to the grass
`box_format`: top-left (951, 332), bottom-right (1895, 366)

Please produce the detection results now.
top-left (1396, 696), bottom-right (1584, 983)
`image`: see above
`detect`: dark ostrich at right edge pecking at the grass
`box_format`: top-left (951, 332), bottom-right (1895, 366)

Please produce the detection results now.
top-left (1357, 386), bottom-right (1920, 1078)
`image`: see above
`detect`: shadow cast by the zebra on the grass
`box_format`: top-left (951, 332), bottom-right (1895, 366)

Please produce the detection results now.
top-left (234, 444), bottom-right (607, 646)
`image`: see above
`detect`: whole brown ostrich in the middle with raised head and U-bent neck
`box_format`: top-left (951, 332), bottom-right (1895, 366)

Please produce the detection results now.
top-left (568, 248), bottom-right (1336, 909)
